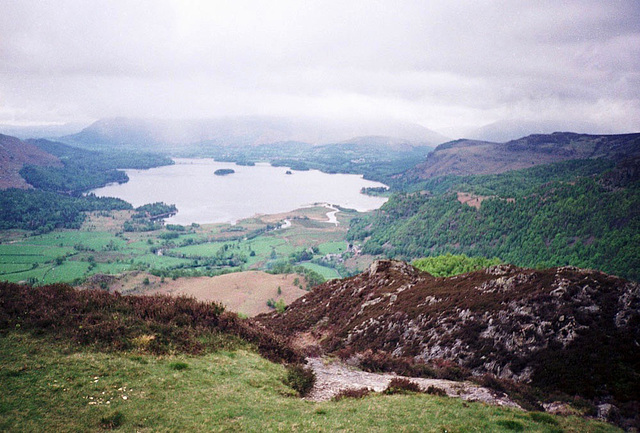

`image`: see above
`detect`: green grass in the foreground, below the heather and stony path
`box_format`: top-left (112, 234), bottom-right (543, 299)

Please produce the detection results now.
top-left (0, 330), bottom-right (619, 432)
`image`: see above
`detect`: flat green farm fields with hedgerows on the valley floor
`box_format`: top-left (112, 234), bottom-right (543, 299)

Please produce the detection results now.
top-left (0, 206), bottom-right (366, 288)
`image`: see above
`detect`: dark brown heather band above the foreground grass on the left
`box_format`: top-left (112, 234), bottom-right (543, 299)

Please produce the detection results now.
top-left (0, 282), bottom-right (303, 363)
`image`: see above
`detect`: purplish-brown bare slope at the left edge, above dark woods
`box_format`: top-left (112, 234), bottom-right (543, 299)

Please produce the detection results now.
top-left (0, 134), bottom-right (62, 189)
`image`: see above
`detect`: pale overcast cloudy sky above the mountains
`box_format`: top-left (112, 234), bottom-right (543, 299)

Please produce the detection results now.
top-left (0, 0), bottom-right (640, 134)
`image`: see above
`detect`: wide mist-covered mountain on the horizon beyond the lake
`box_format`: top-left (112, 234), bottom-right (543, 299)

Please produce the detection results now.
top-left (61, 116), bottom-right (446, 152)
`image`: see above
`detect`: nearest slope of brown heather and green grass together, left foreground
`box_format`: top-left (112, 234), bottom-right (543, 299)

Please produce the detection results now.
top-left (0, 283), bottom-right (620, 433)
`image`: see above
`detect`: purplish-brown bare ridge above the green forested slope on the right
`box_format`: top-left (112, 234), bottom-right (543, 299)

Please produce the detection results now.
top-left (404, 132), bottom-right (640, 179)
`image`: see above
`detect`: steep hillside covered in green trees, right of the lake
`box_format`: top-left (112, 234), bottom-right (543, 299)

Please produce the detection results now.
top-left (349, 159), bottom-right (640, 280)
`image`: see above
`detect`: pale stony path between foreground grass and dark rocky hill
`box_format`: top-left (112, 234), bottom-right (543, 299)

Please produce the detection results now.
top-left (306, 358), bottom-right (520, 408)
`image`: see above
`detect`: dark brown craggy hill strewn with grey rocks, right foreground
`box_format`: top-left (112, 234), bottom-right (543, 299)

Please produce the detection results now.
top-left (258, 261), bottom-right (640, 400)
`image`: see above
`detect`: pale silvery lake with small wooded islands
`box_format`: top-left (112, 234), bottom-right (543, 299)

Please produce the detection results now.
top-left (92, 158), bottom-right (386, 225)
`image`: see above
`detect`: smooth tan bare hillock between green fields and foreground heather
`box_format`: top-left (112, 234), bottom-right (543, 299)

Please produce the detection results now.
top-left (145, 271), bottom-right (307, 316)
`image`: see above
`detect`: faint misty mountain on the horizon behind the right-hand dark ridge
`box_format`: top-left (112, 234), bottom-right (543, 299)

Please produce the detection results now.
top-left (465, 119), bottom-right (614, 142)
